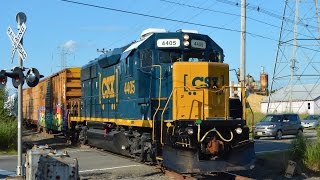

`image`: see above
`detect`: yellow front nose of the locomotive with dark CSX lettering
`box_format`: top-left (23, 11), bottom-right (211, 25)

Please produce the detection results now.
top-left (172, 62), bottom-right (229, 120)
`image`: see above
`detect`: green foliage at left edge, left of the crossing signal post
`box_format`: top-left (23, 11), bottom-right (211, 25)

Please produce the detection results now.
top-left (0, 89), bottom-right (17, 150)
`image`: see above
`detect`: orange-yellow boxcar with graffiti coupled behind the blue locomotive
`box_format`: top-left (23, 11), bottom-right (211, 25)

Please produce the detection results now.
top-left (23, 68), bottom-right (81, 132)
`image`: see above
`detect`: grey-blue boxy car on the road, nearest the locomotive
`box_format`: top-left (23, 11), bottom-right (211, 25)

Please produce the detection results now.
top-left (253, 113), bottom-right (303, 139)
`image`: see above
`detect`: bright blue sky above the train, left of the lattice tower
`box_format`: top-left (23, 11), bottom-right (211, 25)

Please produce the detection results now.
top-left (0, 0), bottom-right (313, 91)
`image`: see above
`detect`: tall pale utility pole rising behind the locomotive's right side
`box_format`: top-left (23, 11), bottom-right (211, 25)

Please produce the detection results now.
top-left (240, 0), bottom-right (247, 119)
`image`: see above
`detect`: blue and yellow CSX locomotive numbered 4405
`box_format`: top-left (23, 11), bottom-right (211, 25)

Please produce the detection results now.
top-left (69, 29), bottom-right (255, 173)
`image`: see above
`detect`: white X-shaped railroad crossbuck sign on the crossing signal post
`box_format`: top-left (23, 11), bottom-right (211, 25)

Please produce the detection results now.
top-left (7, 23), bottom-right (27, 61)
